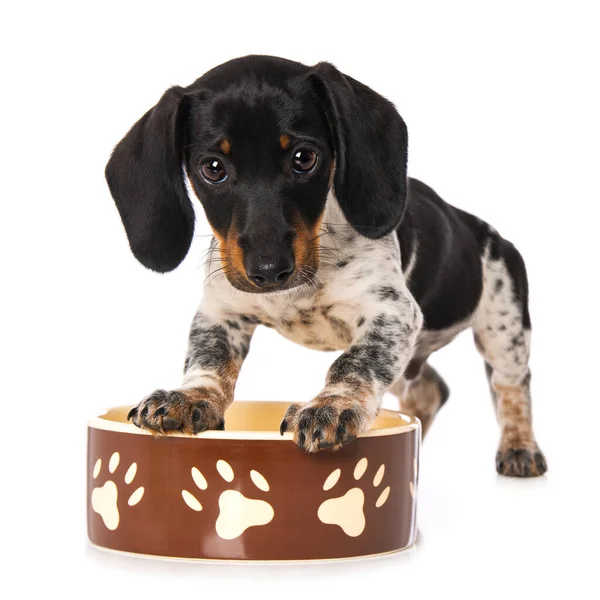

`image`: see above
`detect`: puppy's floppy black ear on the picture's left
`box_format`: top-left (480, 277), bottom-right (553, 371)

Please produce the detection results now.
top-left (106, 87), bottom-right (194, 273)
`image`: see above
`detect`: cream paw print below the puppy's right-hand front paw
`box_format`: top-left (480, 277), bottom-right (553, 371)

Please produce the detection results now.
top-left (317, 458), bottom-right (390, 537)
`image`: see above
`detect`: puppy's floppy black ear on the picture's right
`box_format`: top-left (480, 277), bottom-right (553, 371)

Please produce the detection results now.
top-left (311, 63), bottom-right (408, 238)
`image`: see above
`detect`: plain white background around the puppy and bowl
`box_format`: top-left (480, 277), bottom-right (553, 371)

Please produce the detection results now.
top-left (0, 1), bottom-right (600, 598)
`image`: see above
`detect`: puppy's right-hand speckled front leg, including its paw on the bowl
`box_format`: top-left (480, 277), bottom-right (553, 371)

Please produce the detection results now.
top-left (281, 290), bottom-right (422, 452)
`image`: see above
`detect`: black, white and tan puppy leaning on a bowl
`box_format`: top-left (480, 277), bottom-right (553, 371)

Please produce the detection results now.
top-left (106, 56), bottom-right (546, 477)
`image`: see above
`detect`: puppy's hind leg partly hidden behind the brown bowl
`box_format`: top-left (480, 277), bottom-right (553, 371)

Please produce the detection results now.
top-left (388, 358), bottom-right (450, 435)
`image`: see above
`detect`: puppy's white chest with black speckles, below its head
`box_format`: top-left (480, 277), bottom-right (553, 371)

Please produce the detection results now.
top-left (210, 197), bottom-right (413, 351)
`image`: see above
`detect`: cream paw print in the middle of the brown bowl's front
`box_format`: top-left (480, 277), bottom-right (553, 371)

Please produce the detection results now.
top-left (181, 460), bottom-right (275, 540)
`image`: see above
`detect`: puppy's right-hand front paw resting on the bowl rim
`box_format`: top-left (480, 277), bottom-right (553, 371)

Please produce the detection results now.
top-left (280, 396), bottom-right (374, 453)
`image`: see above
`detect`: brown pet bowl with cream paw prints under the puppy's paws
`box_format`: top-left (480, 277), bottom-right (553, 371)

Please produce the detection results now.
top-left (87, 401), bottom-right (421, 561)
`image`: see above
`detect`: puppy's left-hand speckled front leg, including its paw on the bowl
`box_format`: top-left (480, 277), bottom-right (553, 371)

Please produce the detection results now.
top-left (128, 302), bottom-right (257, 434)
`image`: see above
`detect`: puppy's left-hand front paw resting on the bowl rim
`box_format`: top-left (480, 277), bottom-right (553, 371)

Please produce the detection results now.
top-left (127, 389), bottom-right (225, 434)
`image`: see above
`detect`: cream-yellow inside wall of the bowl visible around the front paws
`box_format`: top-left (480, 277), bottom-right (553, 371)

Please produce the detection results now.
top-left (99, 401), bottom-right (414, 433)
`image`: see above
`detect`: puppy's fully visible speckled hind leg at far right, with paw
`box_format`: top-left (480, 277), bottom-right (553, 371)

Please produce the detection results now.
top-left (473, 236), bottom-right (547, 477)
